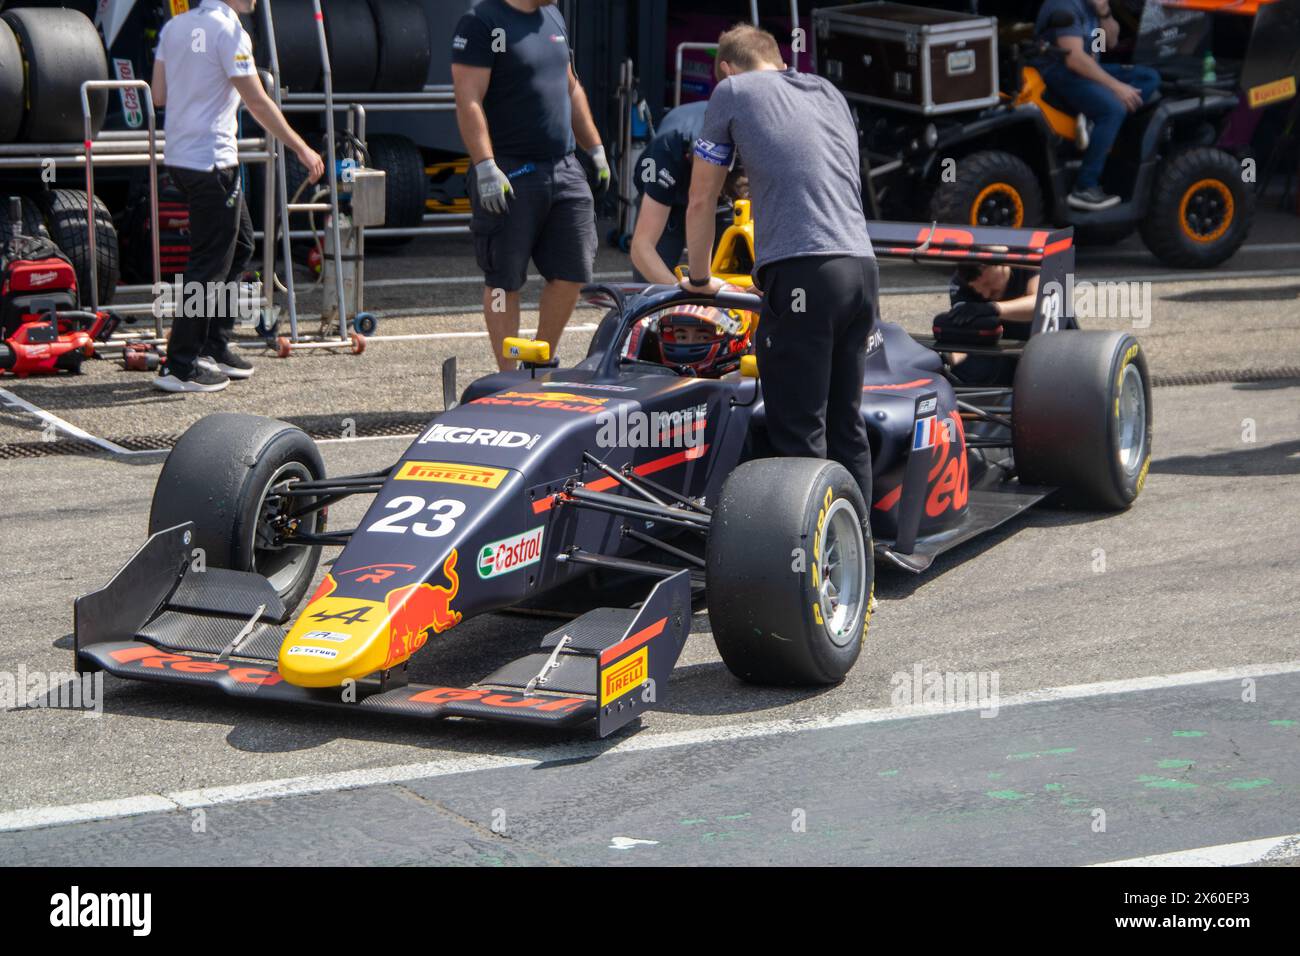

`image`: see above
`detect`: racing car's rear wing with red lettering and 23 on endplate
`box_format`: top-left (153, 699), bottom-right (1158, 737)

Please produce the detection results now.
top-left (867, 221), bottom-right (1078, 336)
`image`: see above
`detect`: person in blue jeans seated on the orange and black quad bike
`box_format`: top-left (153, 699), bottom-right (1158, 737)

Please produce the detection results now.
top-left (1034, 0), bottom-right (1160, 212)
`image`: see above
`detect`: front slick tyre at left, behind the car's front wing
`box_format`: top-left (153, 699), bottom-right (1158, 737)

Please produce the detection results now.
top-left (150, 412), bottom-right (325, 610)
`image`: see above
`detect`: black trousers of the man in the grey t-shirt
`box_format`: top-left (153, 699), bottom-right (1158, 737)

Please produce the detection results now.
top-left (755, 256), bottom-right (880, 507)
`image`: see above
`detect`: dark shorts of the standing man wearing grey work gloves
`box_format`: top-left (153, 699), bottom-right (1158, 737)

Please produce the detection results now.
top-left (469, 153), bottom-right (595, 293)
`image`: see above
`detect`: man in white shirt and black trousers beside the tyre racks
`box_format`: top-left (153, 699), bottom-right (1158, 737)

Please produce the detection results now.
top-left (151, 0), bottom-right (325, 392)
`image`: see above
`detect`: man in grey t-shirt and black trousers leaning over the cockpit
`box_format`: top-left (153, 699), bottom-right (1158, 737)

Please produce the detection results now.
top-left (681, 25), bottom-right (879, 507)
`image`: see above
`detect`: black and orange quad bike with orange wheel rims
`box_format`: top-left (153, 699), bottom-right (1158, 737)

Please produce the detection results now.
top-left (863, 0), bottom-right (1294, 268)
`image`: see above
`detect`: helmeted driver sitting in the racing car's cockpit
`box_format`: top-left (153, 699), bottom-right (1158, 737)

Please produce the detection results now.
top-left (623, 306), bottom-right (757, 378)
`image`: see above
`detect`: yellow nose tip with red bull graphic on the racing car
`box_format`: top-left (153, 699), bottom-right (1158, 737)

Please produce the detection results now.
top-left (280, 550), bottom-right (460, 687)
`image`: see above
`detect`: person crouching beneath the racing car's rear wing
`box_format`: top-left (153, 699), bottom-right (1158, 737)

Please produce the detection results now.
top-left (935, 263), bottom-right (1039, 385)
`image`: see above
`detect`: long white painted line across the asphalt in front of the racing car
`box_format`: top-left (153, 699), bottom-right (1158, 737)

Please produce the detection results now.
top-left (0, 661), bottom-right (1300, 837)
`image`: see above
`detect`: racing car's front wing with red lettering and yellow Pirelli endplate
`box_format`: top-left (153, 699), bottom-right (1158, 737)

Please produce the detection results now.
top-left (75, 524), bottom-right (690, 736)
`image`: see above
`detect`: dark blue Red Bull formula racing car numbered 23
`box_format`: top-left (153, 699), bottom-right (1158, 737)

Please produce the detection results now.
top-left (75, 222), bottom-right (1152, 736)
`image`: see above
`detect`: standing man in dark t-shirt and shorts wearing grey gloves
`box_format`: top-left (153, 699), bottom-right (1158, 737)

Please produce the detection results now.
top-left (451, 0), bottom-right (610, 371)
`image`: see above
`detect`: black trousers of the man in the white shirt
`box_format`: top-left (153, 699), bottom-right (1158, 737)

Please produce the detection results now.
top-left (166, 166), bottom-right (254, 378)
